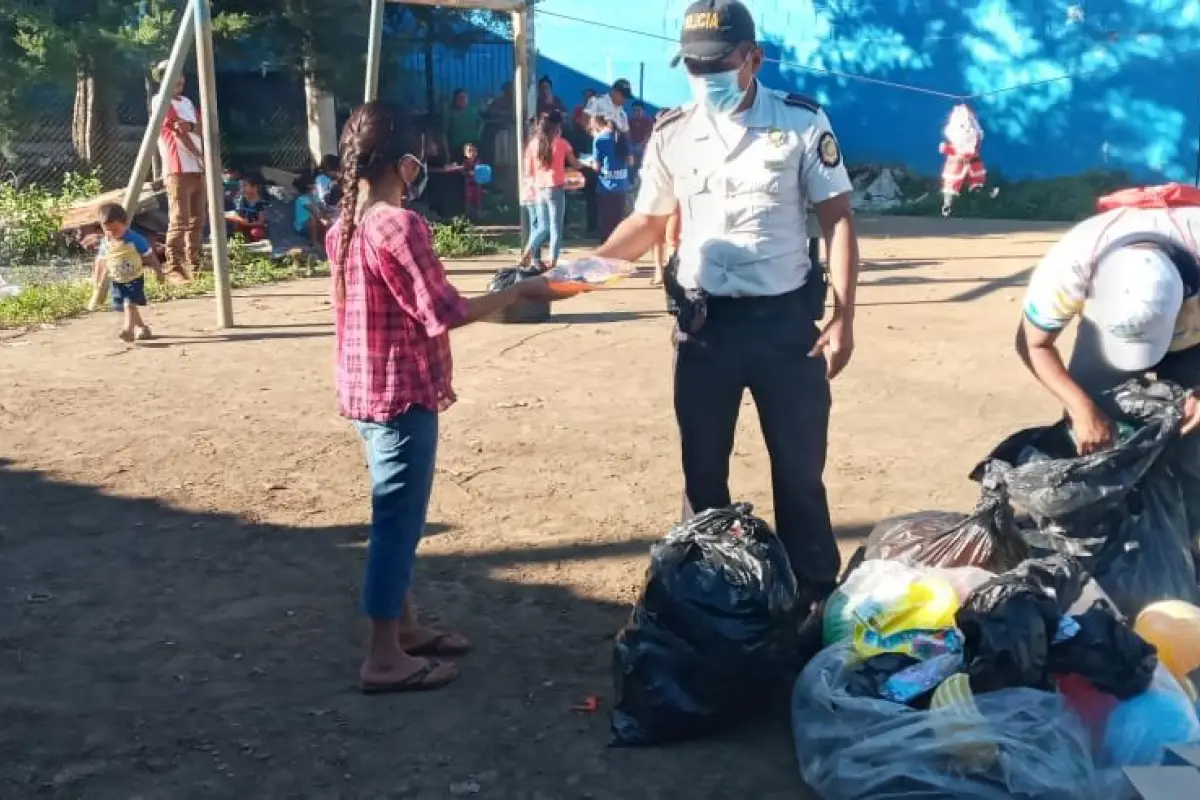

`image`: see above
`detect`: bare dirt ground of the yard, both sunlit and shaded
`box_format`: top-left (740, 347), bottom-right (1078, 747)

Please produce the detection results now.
top-left (0, 218), bottom-right (1070, 800)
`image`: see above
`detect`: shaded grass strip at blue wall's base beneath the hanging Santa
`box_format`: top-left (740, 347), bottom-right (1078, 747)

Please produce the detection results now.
top-left (888, 172), bottom-right (1134, 222)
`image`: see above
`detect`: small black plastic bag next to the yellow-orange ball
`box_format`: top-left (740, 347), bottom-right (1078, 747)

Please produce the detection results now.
top-left (1050, 601), bottom-right (1158, 700)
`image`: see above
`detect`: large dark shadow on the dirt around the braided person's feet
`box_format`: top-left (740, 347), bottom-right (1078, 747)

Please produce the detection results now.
top-left (0, 459), bottom-right (835, 800)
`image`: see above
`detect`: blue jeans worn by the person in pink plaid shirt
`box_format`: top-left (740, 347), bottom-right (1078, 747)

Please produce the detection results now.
top-left (354, 407), bottom-right (438, 620)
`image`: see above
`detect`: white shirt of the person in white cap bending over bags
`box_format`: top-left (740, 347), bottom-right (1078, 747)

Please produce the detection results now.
top-left (1025, 207), bottom-right (1200, 353)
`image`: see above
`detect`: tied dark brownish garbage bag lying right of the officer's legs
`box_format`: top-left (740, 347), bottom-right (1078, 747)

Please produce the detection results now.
top-left (866, 477), bottom-right (1030, 572)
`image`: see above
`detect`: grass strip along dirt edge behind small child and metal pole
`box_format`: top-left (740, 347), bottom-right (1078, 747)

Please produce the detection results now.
top-left (0, 242), bottom-right (329, 329)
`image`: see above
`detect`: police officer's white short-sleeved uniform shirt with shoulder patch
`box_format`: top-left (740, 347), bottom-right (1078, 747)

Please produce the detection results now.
top-left (635, 84), bottom-right (853, 296)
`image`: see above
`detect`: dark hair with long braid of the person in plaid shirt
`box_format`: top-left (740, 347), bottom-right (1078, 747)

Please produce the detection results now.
top-left (334, 101), bottom-right (409, 306)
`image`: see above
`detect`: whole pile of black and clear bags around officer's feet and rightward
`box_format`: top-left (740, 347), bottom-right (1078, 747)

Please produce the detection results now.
top-left (612, 381), bottom-right (1200, 800)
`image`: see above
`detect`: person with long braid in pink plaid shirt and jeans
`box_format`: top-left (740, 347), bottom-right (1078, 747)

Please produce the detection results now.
top-left (325, 101), bottom-right (550, 694)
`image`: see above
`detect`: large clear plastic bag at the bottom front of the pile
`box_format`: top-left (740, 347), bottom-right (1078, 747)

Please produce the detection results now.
top-left (792, 645), bottom-right (1112, 800)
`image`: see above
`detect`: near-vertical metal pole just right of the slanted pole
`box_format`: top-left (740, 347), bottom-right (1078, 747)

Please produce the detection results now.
top-left (193, 0), bottom-right (233, 327)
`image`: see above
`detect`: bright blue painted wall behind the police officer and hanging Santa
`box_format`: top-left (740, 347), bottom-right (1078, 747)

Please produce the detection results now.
top-left (534, 0), bottom-right (1200, 181)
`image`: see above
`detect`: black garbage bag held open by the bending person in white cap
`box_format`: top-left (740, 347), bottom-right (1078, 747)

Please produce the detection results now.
top-left (972, 380), bottom-right (1200, 618)
